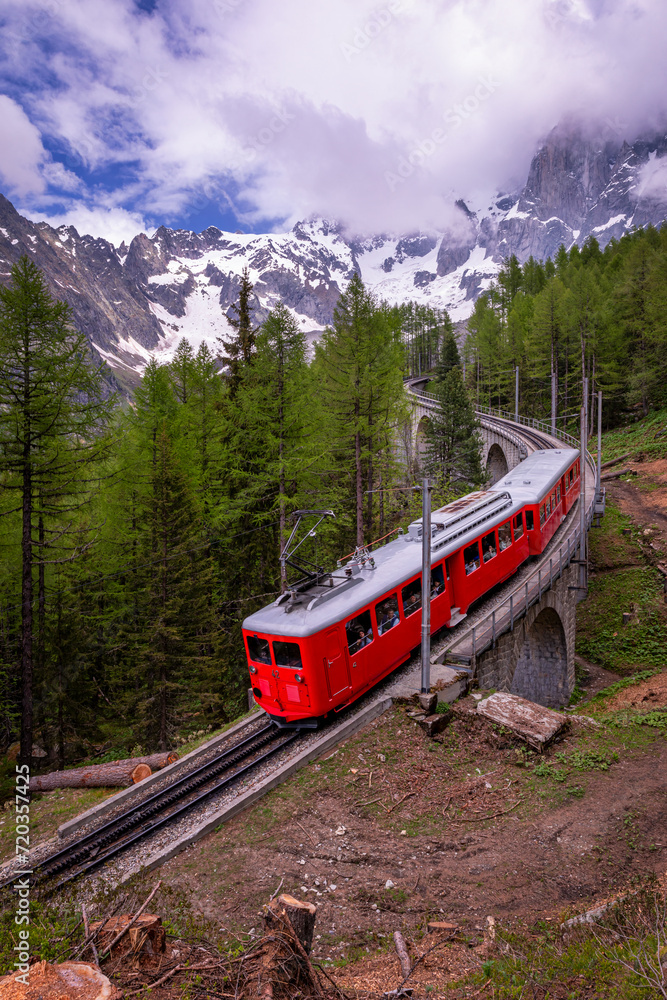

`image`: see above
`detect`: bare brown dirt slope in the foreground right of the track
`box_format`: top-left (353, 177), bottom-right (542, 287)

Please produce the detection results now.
top-left (153, 692), bottom-right (667, 985)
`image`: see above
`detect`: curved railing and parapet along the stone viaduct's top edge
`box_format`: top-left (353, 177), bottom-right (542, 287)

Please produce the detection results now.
top-left (406, 384), bottom-right (598, 667)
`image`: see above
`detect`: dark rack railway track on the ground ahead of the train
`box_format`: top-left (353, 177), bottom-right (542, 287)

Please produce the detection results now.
top-left (0, 723), bottom-right (301, 889)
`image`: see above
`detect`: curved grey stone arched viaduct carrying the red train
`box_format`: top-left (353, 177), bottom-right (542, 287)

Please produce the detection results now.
top-left (406, 384), bottom-right (603, 707)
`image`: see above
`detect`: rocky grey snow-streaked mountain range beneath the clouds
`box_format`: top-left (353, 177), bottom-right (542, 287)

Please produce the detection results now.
top-left (0, 126), bottom-right (667, 384)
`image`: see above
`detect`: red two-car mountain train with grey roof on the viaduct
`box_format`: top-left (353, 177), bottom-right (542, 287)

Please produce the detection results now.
top-left (243, 449), bottom-right (580, 727)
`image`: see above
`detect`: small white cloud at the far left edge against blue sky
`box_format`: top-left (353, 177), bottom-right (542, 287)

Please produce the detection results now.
top-left (0, 94), bottom-right (45, 195)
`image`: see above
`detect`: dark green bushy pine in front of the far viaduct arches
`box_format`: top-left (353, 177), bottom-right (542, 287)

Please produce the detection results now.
top-left (425, 367), bottom-right (485, 498)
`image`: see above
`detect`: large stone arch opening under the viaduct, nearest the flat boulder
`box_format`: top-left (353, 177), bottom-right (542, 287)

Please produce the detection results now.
top-left (510, 608), bottom-right (569, 708)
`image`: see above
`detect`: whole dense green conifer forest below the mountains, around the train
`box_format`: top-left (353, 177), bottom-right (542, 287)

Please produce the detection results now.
top-left (0, 228), bottom-right (667, 767)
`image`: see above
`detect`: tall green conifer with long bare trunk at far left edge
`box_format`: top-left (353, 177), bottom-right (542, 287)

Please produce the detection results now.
top-left (0, 257), bottom-right (111, 762)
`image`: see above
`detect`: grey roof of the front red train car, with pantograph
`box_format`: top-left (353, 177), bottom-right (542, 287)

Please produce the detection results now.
top-left (243, 489), bottom-right (525, 638)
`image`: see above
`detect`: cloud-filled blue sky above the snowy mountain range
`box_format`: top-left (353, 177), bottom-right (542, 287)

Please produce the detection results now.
top-left (0, 0), bottom-right (667, 243)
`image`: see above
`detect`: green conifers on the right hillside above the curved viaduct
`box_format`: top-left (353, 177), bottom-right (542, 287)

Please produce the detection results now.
top-left (464, 226), bottom-right (667, 433)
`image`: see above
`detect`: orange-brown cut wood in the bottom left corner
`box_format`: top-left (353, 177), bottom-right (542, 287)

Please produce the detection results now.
top-left (0, 961), bottom-right (122, 1000)
